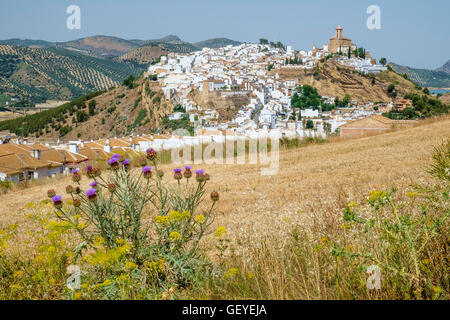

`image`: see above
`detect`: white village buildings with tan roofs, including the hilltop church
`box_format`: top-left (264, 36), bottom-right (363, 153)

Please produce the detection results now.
top-left (0, 26), bottom-right (409, 182)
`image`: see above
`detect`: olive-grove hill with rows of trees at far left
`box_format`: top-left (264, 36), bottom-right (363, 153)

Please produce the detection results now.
top-left (0, 45), bottom-right (143, 102)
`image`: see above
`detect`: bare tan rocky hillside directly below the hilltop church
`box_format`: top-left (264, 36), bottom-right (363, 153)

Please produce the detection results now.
top-left (270, 60), bottom-right (424, 103)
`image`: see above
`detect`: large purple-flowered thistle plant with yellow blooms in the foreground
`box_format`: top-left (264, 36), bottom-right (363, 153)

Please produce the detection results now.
top-left (48, 149), bottom-right (219, 285)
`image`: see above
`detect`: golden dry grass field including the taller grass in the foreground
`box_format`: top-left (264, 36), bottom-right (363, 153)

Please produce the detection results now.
top-left (0, 117), bottom-right (450, 299)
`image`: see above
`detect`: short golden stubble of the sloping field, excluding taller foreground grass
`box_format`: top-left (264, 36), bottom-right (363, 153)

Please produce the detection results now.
top-left (0, 118), bottom-right (450, 244)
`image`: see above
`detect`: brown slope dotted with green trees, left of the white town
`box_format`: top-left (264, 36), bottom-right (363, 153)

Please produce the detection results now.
top-left (0, 79), bottom-right (173, 141)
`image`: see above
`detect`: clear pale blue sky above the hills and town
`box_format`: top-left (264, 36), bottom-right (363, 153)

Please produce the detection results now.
top-left (0, 0), bottom-right (450, 69)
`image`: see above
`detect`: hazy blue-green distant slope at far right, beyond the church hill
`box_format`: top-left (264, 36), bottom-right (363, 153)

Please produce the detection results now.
top-left (389, 63), bottom-right (450, 88)
